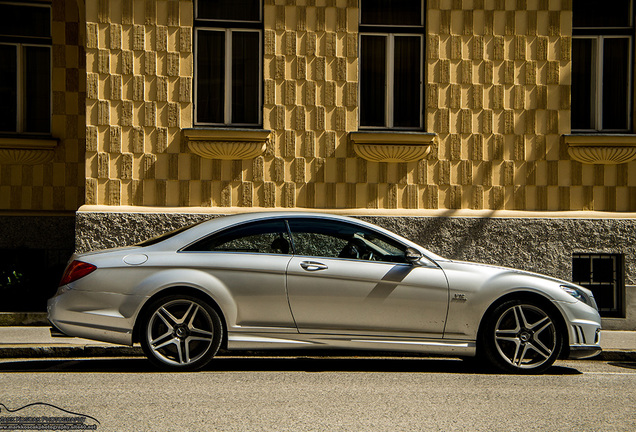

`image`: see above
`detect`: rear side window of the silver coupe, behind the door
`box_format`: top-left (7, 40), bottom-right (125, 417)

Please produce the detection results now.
top-left (184, 220), bottom-right (291, 254)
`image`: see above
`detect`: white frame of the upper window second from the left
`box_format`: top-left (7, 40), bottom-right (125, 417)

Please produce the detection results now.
top-left (194, 27), bottom-right (263, 127)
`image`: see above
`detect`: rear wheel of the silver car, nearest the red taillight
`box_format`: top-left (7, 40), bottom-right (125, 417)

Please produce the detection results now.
top-left (140, 295), bottom-right (223, 371)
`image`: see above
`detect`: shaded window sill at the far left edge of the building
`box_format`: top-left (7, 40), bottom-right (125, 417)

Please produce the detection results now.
top-left (0, 137), bottom-right (58, 165)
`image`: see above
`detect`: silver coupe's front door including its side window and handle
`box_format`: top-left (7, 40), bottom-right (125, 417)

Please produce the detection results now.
top-left (287, 218), bottom-right (448, 338)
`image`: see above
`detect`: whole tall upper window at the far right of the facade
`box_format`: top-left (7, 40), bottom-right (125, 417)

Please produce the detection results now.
top-left (571, 0), bottom-right (634, 132)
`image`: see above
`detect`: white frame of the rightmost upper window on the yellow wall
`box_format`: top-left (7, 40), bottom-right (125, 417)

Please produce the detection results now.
top-left (572, 35), bottom-right (634, 133)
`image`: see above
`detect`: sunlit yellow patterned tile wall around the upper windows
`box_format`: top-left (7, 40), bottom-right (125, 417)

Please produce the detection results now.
top-left (86, 0), bottom-right (636, 211)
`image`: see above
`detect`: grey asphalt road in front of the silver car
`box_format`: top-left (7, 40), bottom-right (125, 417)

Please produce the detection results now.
top-left (0, 357), bottom-right (636, 431)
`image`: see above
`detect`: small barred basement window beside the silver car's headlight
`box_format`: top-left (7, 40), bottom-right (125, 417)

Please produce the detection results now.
top-left (572, 253), bottom-right (625, 318)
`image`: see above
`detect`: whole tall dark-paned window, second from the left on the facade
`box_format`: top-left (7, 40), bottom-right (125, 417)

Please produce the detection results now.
top-left (195, 0), bottom-right (263, 127)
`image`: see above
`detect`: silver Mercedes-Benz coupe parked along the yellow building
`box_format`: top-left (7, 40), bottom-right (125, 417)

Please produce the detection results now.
top-left (48, 212), bottom-right (601, 373)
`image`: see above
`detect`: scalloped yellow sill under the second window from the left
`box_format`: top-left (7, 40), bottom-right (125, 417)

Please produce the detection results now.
top-left (183, 129), bottom-right (272, 160)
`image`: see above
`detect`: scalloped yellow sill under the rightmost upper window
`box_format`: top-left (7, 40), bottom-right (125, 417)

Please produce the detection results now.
top-left (563, 134), bottom-right (636, 165)
